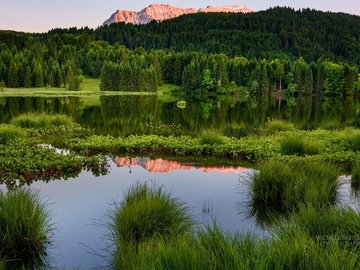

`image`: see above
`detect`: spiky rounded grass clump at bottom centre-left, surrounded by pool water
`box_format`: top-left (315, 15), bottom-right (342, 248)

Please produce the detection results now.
top-left (110, 184), bottom-right (193, 268)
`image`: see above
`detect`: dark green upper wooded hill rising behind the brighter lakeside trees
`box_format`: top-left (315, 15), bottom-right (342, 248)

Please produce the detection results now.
top-left (41, 8), bottom-right (360, 64)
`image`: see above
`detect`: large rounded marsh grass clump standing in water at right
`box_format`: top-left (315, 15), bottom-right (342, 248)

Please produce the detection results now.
top-left (249, 161), bottom-right (341, 221)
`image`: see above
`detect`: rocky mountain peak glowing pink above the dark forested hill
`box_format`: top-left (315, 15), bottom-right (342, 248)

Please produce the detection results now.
top-left (103, 4), bottom-right (253, 25)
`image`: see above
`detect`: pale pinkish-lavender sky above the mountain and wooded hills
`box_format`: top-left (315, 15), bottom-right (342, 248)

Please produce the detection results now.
top-left (0, 0), bottom-right (360, 32)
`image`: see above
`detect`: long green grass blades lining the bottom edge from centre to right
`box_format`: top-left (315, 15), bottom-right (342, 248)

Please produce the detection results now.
top-left (111, 220), bottom-right (359, 270)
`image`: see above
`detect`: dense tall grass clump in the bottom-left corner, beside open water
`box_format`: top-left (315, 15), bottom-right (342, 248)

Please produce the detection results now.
top-left (0, 189), bottom-right (51, 269)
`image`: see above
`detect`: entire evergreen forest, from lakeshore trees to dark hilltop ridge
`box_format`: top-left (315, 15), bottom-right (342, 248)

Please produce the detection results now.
top-left (0, 8), bottom-right (360, 95)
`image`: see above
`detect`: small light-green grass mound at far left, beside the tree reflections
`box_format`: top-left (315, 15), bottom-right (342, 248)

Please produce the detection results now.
top-left (11, 113), bottom-right (73, 128)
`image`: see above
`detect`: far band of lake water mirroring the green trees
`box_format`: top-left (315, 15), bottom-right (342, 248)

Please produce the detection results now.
top-left (0, 95), bottom-right (360, 136)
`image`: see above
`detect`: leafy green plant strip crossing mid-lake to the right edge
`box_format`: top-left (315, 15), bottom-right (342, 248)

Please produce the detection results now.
top-left (66, 129), bottom-right (360, 169)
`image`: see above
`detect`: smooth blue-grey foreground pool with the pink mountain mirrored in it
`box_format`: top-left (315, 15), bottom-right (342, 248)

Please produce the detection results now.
top-left (31, 157), bottom-right (258, 269)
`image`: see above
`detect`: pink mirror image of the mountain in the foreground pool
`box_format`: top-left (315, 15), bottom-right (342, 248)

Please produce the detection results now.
top-left (114, 157), bottom-right (247, 173)
